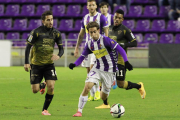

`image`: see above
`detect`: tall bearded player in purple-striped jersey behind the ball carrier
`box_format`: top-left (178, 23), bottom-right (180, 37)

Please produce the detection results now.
top-left (74, 0), bottom-right (109, 100)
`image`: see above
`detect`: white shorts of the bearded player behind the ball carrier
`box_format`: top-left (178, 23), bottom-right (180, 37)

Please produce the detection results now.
top-left (81, 53), bottom-right (96, 67)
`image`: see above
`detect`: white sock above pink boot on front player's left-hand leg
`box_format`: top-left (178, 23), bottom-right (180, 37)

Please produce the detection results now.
top-left (78, 95), bottom-right (88, 113)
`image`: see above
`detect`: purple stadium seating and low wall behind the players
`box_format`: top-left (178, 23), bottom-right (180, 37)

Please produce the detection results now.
top-left (0, 0), bottom-right (180, 67)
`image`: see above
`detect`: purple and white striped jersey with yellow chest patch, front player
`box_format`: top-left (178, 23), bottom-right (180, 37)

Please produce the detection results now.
top-left (79, 35), bottom-right (127, 72)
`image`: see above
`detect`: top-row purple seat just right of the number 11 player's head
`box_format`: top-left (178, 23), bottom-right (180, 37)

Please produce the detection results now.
top-left (126, 5), bottom-right (142, 17)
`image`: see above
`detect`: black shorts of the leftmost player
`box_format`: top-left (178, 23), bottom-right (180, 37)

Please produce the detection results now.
top-left (30, 64), bottom-right (57, 84)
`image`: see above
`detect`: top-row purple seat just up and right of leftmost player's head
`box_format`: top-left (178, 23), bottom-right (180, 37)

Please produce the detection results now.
top-left (52, 5), bottom-right (66, 17)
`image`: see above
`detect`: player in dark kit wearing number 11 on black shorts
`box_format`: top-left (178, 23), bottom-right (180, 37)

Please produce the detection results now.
top-left (109, 9), bottom-right (146, 99)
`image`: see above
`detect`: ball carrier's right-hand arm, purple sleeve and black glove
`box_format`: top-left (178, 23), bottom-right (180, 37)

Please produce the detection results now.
top-left (116, 44), bottom-right (133, 71)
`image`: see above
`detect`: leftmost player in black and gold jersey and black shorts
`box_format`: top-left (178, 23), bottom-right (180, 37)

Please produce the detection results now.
top-left (24, 11), bottom-right (64, 115)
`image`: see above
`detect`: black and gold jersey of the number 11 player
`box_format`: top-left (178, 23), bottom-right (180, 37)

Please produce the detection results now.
top-left (109, 24), bottom-right (136, 65)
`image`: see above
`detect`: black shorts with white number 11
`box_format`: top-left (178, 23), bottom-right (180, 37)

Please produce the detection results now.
top-left (116, 64), bottom-right (126, 81)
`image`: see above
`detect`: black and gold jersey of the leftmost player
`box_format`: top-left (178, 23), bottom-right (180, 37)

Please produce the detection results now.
top-left (27, 26), bottom-right (62, 65)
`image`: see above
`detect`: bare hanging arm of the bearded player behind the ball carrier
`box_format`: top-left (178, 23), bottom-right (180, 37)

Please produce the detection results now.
top-left (74, 28), bottom-right (85, 57)
